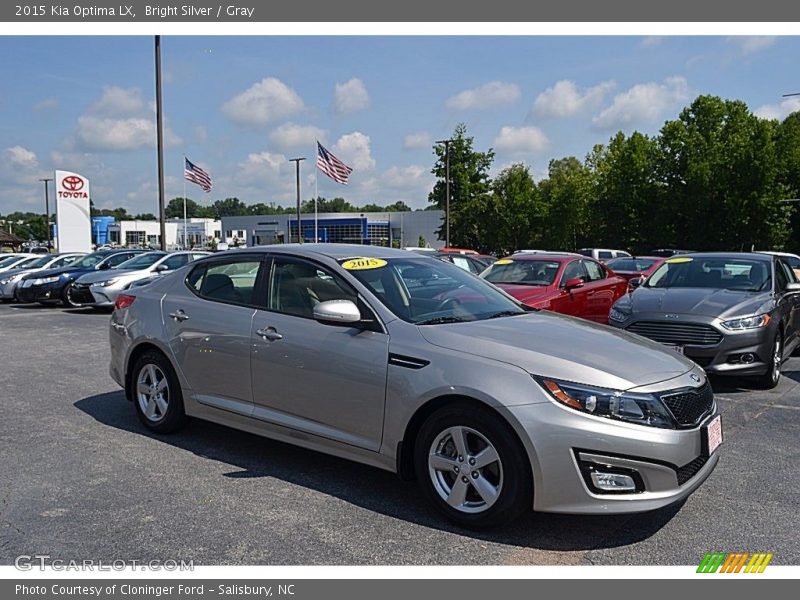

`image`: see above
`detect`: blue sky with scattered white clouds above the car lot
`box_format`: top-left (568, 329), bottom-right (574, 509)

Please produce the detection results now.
top-left (0, 36), bottom-right (800, 214)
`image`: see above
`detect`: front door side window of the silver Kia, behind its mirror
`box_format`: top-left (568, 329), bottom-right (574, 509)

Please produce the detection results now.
top-left (267, 257), bottom-right (358, 319)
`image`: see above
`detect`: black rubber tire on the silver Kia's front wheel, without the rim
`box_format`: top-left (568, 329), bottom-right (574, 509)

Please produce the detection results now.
top-left (414, 402), bottom-right (533, 529)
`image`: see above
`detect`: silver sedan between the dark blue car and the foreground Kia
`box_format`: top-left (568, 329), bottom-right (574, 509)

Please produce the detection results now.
top-left (69, 251), bottom-right (210, 308)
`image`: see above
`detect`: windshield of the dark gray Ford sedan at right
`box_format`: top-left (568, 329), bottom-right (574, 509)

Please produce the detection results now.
top-left (645, 256), bottom-right (772, 292)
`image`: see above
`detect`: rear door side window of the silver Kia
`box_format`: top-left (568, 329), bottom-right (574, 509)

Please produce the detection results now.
top-left (186, 257), bottom-right (261, 304)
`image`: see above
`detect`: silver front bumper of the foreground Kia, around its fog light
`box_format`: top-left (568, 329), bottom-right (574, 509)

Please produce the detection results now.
top-left (509, 392), bottom-right (719, 514)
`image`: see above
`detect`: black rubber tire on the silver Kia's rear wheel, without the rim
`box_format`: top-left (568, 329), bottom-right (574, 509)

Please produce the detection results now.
top-left (128, 350), bottom-right (189, 433)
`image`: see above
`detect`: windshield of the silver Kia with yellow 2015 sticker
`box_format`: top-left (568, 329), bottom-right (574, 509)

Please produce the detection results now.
top-left (341, 257), bottom-right (525, 325)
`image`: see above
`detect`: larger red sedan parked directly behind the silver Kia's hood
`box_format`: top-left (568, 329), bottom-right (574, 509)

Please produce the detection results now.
top-left (481, 254), bottom-right (628, 324)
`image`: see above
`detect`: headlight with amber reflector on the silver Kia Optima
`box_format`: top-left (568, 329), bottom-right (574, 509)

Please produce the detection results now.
top-left (537, 378), bottom-right (675, 429)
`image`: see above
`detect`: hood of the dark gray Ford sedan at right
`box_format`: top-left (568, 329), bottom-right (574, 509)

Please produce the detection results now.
top-left (629, 287), bottom-right (771, 318)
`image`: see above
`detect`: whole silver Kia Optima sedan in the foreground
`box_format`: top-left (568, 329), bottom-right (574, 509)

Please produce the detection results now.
top-left (110, 244), bottom-right (722, 527)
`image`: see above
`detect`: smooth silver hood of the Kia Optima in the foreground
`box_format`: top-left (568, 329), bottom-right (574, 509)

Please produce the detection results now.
top-left (419, 311), bottom-right (695, 390)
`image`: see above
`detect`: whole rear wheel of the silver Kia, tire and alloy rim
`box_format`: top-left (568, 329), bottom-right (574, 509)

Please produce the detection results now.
top-left (130, 351), bottom-right (188, 433)
